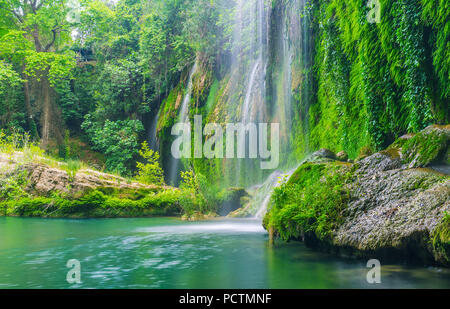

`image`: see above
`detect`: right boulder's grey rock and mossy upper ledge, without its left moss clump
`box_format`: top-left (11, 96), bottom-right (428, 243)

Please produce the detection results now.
top-left (270, 126), bottom-right (450, 266)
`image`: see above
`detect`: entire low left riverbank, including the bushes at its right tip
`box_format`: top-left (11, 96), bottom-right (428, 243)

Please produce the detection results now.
top-left (0, 144), bottom-right (246, 217)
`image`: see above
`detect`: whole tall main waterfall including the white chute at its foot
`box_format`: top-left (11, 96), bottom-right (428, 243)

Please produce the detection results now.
top-left (230, 0), bottom-right (312, 218)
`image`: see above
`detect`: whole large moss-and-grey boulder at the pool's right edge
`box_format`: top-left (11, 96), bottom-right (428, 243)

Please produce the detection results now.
top-left (264, 126), bottom-right (450, 266)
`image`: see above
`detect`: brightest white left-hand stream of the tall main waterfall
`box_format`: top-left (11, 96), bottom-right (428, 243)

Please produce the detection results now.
top-left (231, 0), bottom-right (269, 185)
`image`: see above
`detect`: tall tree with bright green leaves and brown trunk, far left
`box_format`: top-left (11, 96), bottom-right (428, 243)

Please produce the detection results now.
top-left (0, 0), bottom-right (75, 144)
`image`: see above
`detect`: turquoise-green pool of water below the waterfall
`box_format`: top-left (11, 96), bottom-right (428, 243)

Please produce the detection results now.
top-left (0, 217), bottom-right (450, 288)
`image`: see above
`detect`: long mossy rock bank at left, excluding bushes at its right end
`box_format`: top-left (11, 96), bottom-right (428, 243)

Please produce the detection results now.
top-left (0, 152), bottom-right (182, 218)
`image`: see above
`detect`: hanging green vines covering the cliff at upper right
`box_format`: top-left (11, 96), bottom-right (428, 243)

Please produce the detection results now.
top-left (310, 0), bottom-right (449, 158)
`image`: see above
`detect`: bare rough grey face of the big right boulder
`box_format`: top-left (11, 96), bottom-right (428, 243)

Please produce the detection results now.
top-left (332, 169), bottom-right (450, 265)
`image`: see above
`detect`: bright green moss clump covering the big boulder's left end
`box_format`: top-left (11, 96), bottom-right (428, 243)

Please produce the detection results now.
top-left (264, 163), bottom-right (352, 240)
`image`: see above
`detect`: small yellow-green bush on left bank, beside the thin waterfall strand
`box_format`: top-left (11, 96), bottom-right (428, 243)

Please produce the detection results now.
top-left (136, 141), bottom-right (164, 185)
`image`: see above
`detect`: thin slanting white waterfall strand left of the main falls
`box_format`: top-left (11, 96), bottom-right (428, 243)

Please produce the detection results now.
top-left (168, 61), bottom-right (197, 186)
